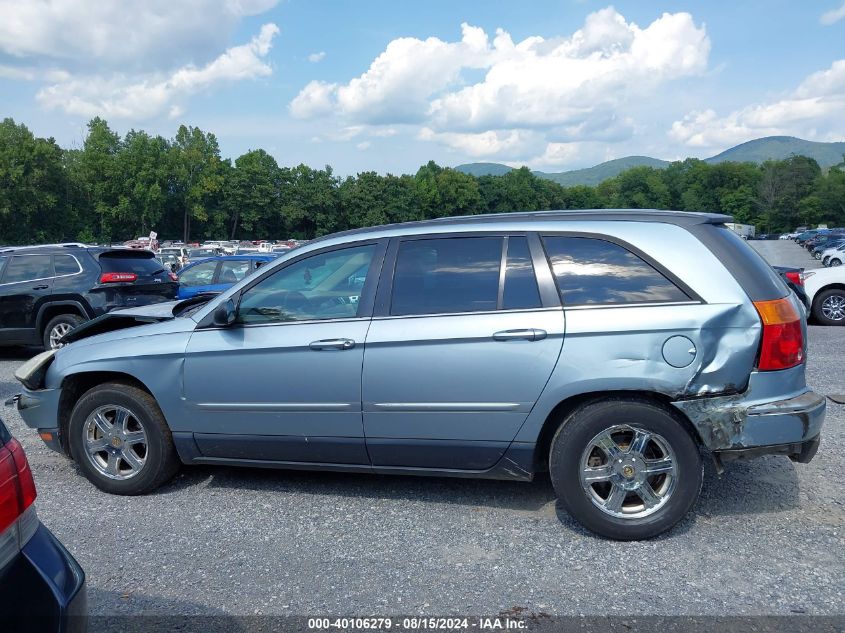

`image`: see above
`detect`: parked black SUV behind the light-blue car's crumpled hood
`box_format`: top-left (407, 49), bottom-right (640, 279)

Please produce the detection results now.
top-left (0, 244), bottom-right (179, 349)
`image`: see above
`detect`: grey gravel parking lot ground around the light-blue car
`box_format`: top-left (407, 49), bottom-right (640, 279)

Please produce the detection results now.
top-left (0, 241), bottom-right (845, 615)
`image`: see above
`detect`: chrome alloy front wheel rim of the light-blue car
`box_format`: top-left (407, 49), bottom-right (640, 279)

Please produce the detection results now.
top-left (82, 405), bottom-right (147, 480)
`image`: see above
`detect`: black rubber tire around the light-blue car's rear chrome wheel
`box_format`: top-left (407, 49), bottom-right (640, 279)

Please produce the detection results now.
top-left (549, 398), bottom-right (704, 541)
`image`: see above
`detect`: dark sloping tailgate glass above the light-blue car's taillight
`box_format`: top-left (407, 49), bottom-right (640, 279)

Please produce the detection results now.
top-left (687, 224), bottom-right (790, 301)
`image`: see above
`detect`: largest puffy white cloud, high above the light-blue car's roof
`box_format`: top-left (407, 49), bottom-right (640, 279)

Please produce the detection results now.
top-left (289, 7), bottom-right (710, 160)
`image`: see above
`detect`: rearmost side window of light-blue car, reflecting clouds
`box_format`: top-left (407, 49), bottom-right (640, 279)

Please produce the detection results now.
top-left (543, 236), bottom-right (690, 306)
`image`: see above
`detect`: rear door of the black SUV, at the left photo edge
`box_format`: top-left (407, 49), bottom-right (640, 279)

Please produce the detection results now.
top-left (0, 254), bottom-right (53, 343)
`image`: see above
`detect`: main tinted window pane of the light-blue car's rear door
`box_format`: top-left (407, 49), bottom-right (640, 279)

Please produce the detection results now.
top-left (390, 237), bottom-right (502, 315)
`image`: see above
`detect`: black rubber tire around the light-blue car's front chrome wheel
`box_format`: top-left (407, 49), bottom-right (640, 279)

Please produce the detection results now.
top-left (68, 382), bottom-right (180, 495)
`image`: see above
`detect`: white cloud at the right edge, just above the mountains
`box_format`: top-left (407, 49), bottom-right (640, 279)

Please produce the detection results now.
top-left (669, 59), bottom-right (845, 148)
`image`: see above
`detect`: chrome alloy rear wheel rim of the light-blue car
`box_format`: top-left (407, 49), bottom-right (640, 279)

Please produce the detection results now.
top-left (579, 424), bottom-right (678, 519)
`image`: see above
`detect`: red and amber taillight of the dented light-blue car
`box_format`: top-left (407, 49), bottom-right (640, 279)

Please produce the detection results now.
top-left (754, 297), bottom-right (804, 371)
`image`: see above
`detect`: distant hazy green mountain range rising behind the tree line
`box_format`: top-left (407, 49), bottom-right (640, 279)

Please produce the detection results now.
top-left (455, 136), bottom-right (845, 187)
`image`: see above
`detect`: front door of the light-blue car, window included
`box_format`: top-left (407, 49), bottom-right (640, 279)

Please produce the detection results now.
top-left (183, 241), bottom-right (385, 464)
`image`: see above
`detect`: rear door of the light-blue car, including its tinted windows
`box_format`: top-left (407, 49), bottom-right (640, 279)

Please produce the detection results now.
top-left (362, 234), bottom-right (564, 470)
